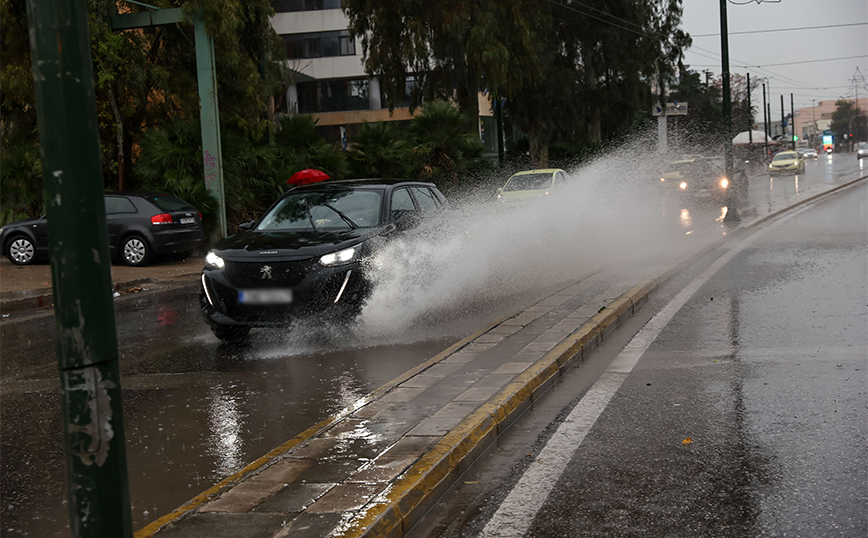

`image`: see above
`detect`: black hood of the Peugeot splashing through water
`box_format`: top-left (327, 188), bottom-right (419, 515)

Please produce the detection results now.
top-left (212, 228), bottom-right (383, 261)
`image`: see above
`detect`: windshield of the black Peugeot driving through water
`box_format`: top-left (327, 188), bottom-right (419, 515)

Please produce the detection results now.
top-left (256, 189), bottom-right (383, 232)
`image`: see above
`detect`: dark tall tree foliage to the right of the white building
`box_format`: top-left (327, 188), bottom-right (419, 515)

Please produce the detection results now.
top-left (343, 0), bottom-right (690, 164)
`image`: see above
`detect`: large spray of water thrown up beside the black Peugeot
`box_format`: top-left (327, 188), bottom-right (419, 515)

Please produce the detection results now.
top-left (357, 135), bottom-right (708, 341)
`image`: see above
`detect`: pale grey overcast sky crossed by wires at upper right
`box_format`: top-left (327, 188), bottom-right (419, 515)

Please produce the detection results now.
top-left (682, 0), bottom-right (868, 111)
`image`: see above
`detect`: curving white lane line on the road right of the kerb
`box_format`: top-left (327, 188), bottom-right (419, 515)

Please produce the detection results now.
top-left (480, 207), bottom-right (807, 538)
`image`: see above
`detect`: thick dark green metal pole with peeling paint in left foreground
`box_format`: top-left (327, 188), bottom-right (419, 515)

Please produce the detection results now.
top-left (27, 0), bottom-right (132, 538)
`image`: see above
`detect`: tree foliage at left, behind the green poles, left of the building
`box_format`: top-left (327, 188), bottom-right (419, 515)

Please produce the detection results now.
top-left (0, 0), bottom-right (285, 222)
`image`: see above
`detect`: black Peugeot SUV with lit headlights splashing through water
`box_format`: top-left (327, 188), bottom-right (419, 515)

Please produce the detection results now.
top-left (199, 179), bottom-right (446, 341)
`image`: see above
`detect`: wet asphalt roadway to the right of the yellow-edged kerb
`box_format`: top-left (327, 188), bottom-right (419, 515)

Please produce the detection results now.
top-left (410, 183), bottom-right (868, 538)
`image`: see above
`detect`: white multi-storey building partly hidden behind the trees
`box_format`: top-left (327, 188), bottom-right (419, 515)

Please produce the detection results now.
top-left (271, 0), bottom-right (496, 153)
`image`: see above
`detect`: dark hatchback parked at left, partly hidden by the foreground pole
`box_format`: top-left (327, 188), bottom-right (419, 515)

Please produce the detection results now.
top-left (0, 192), bottom-right (204, 266)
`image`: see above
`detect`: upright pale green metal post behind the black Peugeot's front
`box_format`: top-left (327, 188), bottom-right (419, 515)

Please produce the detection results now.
top-left (193, 16), bottom-right (226, 237)
